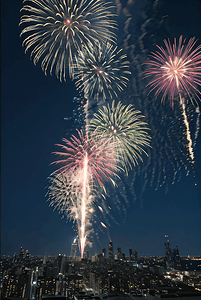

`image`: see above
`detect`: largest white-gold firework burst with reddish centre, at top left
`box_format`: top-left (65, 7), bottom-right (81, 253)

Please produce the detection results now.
top-left (20, 0), bottom-right (117, 81)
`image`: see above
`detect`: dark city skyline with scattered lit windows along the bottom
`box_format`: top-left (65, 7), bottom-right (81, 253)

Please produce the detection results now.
top-left (0, 240), bottom-right (201, 300)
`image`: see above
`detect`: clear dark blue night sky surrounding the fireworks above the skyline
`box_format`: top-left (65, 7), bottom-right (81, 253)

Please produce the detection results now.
top-left (1, 0), bottom-right (201, 256)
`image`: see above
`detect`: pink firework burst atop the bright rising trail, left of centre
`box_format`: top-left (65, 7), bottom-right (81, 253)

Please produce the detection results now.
top-left (52, 130), bottom-right (118, 187)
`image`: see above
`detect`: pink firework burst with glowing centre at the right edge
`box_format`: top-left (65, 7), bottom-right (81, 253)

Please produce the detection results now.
top-left (145, 36), bottom-right (201, 107)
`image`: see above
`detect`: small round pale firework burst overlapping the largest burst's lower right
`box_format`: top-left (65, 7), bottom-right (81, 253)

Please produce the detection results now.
top-left (73, 43), bottom-right (130, 100)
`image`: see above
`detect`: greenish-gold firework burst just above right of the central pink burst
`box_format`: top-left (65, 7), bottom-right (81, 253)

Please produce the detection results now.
top-left (89, 101), bottom-right (150, 171)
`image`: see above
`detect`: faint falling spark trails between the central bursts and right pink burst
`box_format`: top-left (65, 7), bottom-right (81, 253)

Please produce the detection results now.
top-left (117, 0), bottom-right (199, 199)
